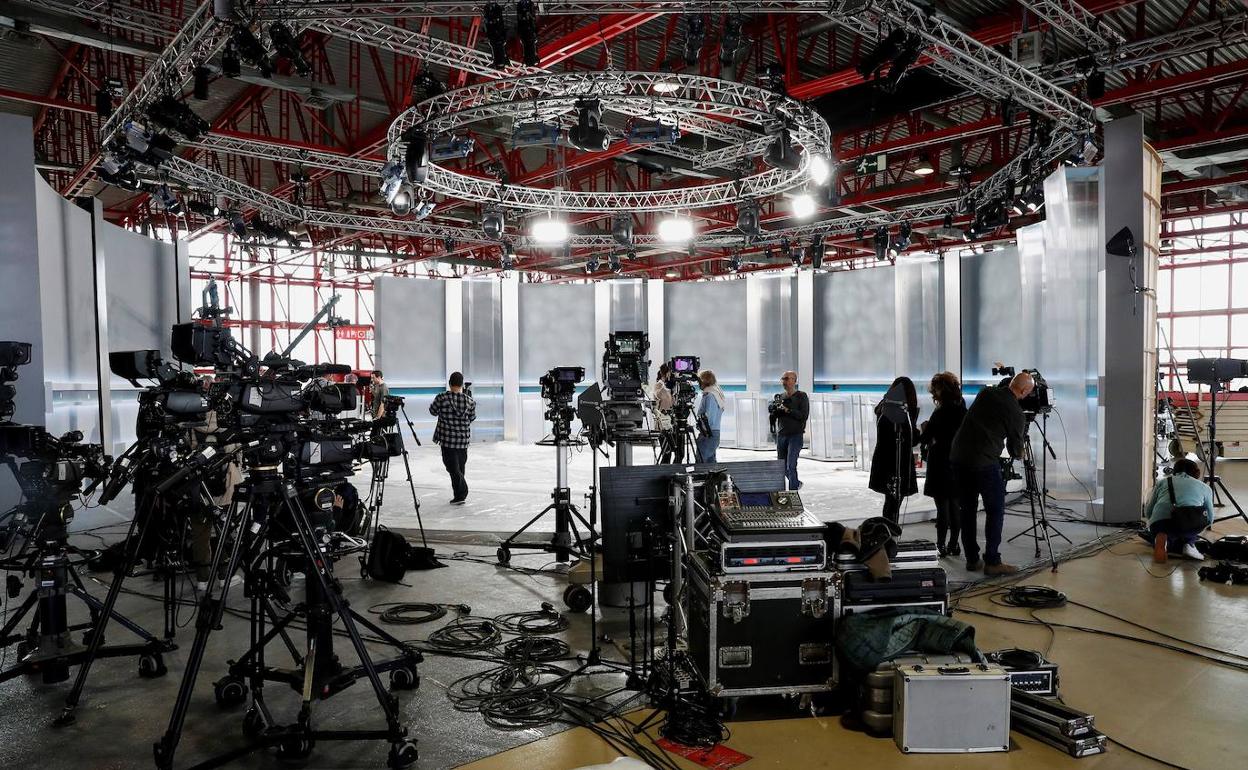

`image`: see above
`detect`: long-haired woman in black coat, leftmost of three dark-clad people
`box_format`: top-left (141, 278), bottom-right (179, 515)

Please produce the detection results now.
top-left (867, 377), bottom-right (919, 523)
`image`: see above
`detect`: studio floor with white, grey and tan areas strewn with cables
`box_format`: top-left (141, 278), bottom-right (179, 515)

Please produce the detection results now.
top-left (0, 444), bottom-right (1248, 770)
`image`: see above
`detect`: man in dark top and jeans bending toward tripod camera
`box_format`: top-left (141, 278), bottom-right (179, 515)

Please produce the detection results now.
top-left (948, 372), bottom-right (1036, 575)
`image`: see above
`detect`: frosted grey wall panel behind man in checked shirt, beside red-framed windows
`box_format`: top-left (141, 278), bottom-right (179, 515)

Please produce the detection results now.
top-left (373, 276), bottom-right (449, 387)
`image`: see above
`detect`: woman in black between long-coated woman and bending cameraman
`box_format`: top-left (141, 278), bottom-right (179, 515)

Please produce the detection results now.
top-left (919, 372), bottom-right (966, 557)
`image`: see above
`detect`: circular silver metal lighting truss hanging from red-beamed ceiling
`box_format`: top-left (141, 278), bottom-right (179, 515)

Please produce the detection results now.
top-left (388, 72), bottom-right (831, 213)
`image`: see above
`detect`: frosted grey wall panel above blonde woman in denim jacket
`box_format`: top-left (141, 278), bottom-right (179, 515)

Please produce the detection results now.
top-left (668, 281), bottom-right (746, 384)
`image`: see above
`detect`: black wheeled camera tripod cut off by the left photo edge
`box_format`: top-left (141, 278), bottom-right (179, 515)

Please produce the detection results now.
top-left (0, 510), bottom-right (175, 684)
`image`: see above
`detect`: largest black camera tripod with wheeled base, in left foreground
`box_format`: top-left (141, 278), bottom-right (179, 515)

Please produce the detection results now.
top-left (155, 465), bottom-right (421, 770)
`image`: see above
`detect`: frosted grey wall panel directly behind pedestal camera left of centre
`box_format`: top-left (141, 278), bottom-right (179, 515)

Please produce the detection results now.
top-left (519, 283), bottom-right (595, 387)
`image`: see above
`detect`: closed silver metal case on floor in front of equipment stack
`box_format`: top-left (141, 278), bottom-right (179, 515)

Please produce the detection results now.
top-left (892, 663), bottom-right (1010, 754)
